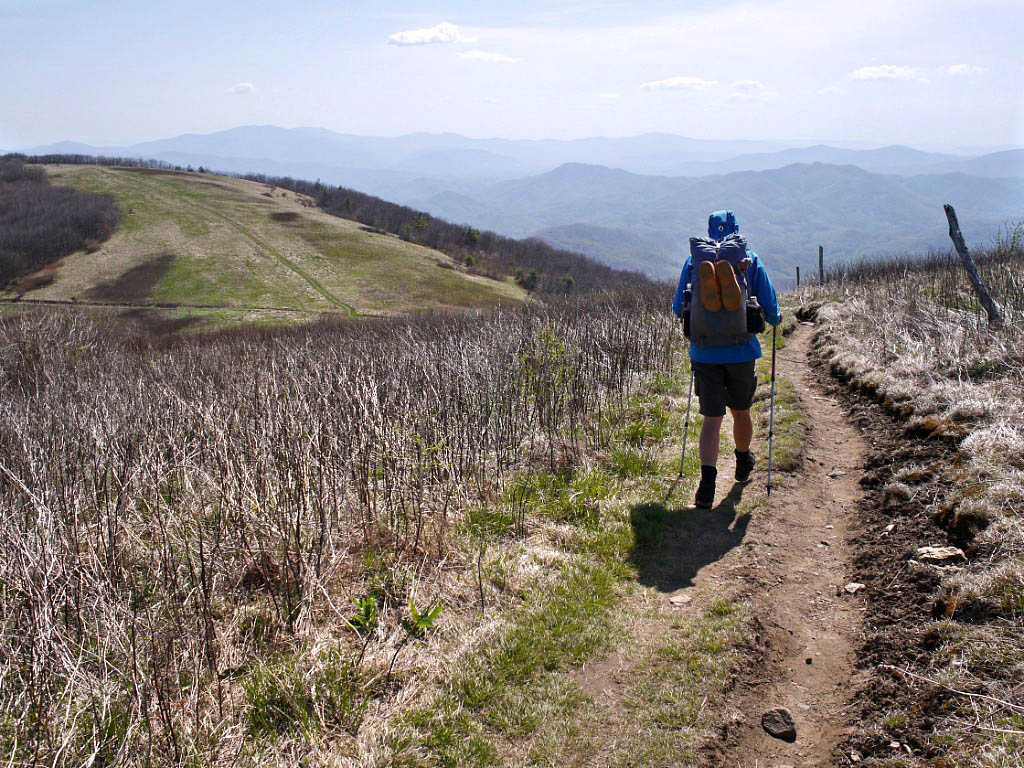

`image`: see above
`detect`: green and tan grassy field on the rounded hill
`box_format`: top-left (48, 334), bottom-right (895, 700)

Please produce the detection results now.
top-left (5, 166), bottom-right (525, 325)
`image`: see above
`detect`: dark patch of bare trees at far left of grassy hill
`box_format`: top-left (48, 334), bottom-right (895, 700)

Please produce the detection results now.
top-left (0, 155), bottom-right (121, 285)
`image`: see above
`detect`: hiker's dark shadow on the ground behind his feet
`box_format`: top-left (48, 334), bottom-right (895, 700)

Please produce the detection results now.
top-left (630, 482), bottom-right (751, 592)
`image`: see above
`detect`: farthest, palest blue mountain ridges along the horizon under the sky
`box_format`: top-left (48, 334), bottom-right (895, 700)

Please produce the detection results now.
top-left (26, 125), bottom-right (1024, 195)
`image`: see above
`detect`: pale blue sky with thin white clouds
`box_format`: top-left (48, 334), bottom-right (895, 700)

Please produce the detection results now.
top-left (0, 0), bottom-right (1024, 152)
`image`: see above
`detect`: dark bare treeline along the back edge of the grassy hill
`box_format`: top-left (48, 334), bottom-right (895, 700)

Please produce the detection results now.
top-left (19, 155), bottom-right (653, 295)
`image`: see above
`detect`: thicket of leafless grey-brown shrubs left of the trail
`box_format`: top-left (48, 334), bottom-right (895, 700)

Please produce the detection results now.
top-left (0, 295), bottom-right (672, 765)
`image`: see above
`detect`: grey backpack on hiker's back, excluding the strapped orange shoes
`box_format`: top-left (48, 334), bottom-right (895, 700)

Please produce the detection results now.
top-left (684, 234), bottom-right (764, 347)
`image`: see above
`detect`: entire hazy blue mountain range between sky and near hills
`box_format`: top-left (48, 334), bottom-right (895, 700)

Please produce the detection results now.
top-left (22, 126), bottom-right (1024, 278)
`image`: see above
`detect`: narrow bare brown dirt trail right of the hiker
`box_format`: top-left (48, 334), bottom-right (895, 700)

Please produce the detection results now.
top-left (727, 327), bottom-right (866, 768)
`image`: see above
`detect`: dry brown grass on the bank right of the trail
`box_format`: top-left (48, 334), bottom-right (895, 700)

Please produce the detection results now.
top-left (801, 243), bottom-right (1024, 766)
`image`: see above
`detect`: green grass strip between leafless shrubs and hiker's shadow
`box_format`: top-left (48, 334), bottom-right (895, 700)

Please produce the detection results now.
top-left (399, 460), bottom-right (634, 766)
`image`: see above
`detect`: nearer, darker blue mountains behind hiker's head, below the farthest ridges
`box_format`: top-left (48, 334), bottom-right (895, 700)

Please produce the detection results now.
top-left (411, 163), bottom-right (1024, 282)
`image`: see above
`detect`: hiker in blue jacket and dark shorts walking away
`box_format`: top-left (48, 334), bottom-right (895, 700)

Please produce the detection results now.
top-left (672, 211), bottom-right (782, 509)
